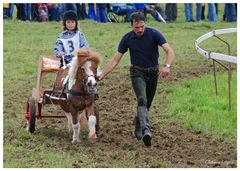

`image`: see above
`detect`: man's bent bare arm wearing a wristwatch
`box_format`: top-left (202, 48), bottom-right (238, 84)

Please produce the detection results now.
top-left (160, 43), bottom-right (175, 78)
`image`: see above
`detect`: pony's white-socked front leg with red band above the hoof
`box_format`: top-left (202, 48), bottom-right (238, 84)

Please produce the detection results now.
top-left (87, 105), bottom-right (97, 139)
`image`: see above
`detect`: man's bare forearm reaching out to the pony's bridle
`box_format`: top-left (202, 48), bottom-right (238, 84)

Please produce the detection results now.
top-left (98, 52), bottom-right (123, 81)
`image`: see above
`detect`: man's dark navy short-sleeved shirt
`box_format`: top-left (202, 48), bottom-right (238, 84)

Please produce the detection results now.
top-left (118, 27), bottom-right (166, 68)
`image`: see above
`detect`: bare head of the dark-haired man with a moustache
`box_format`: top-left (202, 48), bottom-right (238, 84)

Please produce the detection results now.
top-left (130, 11), bottom-right (145, 37)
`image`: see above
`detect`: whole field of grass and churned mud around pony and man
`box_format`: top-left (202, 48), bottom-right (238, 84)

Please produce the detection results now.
top-left (3, 4), bottom-right (237, 168)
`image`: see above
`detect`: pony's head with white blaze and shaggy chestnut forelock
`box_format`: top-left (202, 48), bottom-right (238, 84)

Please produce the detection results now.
top-left (69, 48), bottom-right (101, 94)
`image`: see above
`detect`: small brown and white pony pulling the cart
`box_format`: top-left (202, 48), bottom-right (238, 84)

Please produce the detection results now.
top-left (53, 48), bottom-right (101, 143)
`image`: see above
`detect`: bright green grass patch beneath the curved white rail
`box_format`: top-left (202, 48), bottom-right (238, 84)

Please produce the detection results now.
top-left (167, 73), bottom-right (237, 138)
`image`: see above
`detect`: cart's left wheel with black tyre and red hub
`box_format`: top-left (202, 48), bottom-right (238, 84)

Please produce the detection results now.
top-left (26, 97), bottom-right (36, 133)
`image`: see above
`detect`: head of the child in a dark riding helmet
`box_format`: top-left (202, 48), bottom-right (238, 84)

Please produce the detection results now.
top-left (63, 10), bottom-right (78, 31)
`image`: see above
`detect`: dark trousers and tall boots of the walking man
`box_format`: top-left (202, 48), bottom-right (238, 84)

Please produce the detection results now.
top-left (130, 66), bottom-right (159, 146)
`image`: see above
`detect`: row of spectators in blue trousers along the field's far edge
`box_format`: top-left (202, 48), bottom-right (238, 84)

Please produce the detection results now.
top-left (3, 3), bottom-right (237, 23)
